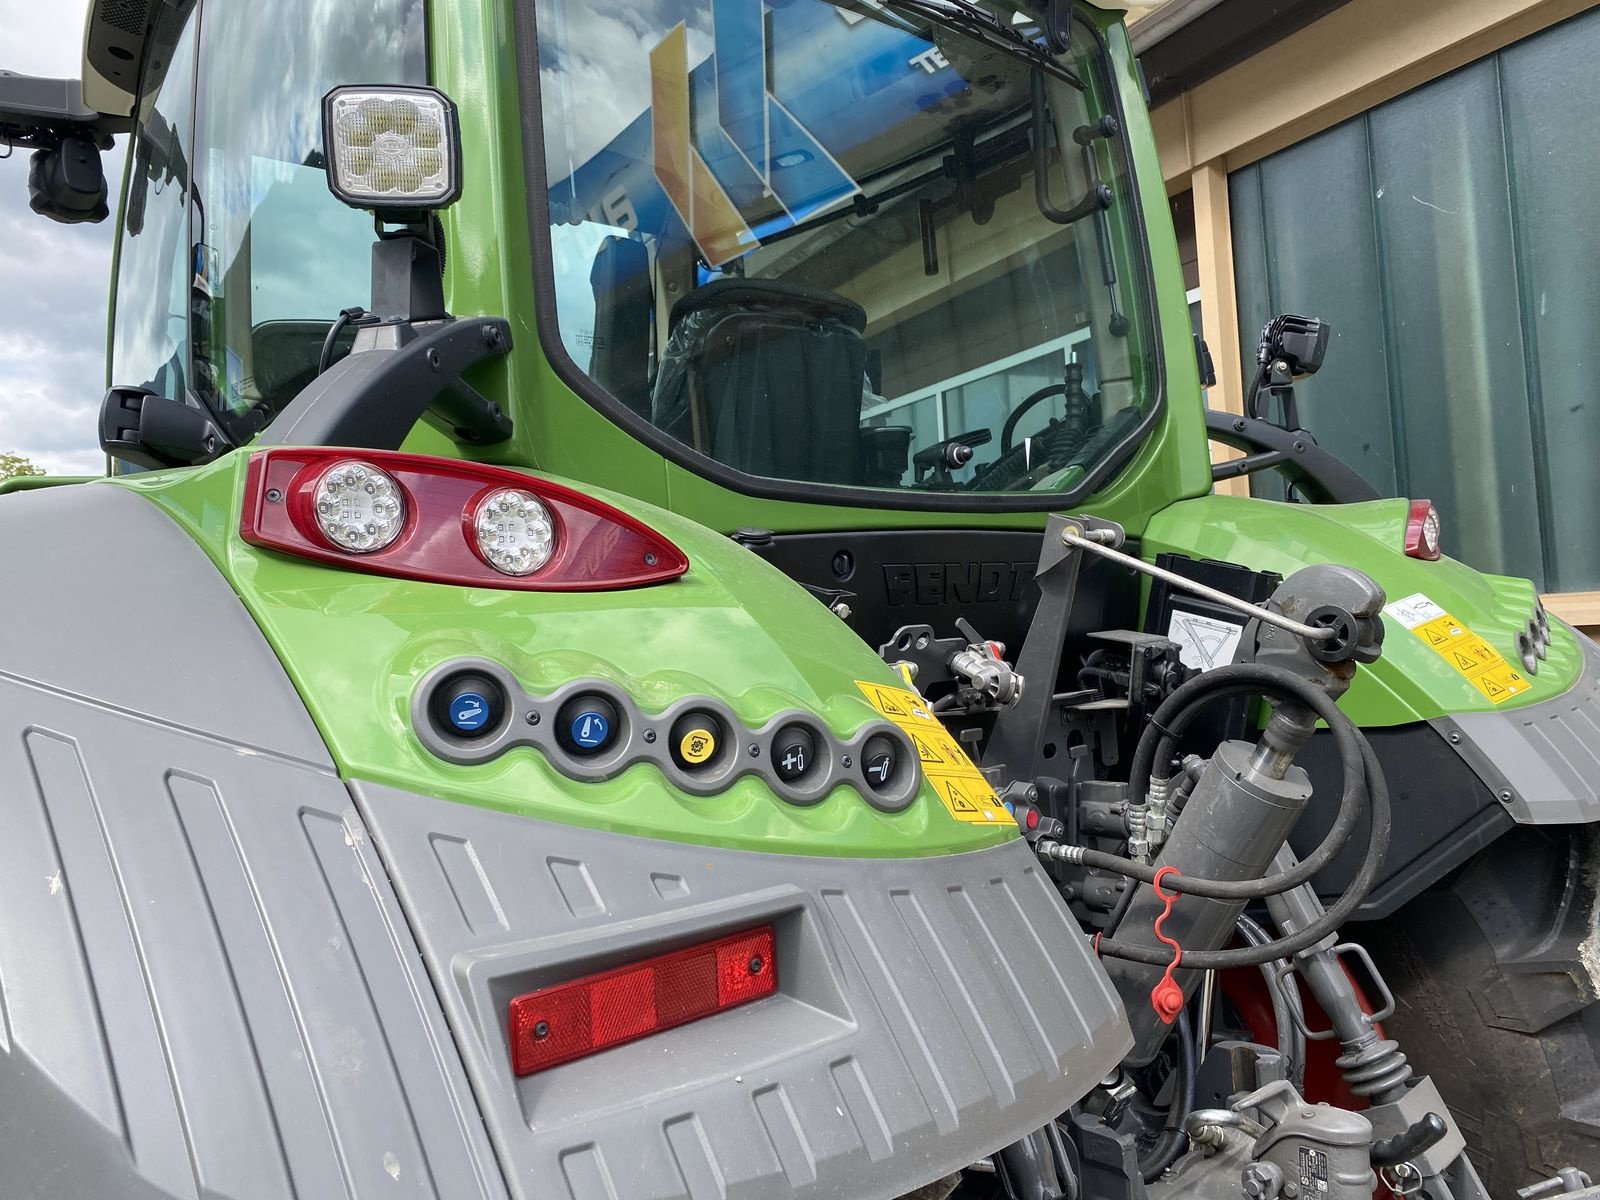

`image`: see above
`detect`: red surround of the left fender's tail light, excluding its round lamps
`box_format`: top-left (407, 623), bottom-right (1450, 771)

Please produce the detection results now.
top-left (238, 450), bottom-right (690, 592)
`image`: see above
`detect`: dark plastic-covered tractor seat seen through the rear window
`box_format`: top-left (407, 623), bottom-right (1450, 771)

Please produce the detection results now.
top-left (651, 278), bottom-right (867, 483)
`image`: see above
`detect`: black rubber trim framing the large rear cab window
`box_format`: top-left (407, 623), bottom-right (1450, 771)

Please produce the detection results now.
top-left (514, 0), bottom-right (1166, 512)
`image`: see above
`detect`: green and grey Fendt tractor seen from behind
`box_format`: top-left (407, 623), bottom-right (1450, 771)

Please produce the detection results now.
top-left (0, 0), bottom-right (1600, 1200)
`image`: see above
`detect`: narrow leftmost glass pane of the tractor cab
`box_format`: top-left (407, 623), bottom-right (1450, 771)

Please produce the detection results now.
top-left (110, 5), bottom-right (198, 400)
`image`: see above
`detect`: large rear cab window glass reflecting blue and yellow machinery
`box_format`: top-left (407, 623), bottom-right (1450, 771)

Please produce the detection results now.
top-left (538, 0), bottom-right (1158, 494)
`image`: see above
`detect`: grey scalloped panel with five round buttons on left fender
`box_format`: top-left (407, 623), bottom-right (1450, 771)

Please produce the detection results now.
top-left (411, 659), bottom-right (922, 813)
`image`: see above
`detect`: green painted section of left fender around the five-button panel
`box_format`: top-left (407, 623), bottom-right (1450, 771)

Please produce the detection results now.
top-left (106, 453), bottom-right (1018, 858)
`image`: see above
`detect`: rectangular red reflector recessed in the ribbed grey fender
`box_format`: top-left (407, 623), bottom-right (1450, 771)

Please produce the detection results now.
top-left (510, 926), bottom-right (778, 1075)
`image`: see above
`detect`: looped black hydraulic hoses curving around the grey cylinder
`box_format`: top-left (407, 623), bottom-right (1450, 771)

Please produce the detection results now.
top-left (1074, 664), bottom-right (1390, 971)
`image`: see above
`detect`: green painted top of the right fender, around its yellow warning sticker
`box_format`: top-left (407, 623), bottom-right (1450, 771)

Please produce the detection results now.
top-left (1139, 496), bottom-right (1582, 726)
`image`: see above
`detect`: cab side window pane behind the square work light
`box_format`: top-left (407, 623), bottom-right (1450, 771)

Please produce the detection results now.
top-left (194, 0), bottom-right (427, 442)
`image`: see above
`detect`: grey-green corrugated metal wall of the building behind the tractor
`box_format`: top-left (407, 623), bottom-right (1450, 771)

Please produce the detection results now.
top-left (1229, 10), bottom-right (1600, 590)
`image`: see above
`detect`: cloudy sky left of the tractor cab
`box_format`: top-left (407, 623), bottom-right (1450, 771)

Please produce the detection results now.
top-left (0, 0), bottom-right (125, 474)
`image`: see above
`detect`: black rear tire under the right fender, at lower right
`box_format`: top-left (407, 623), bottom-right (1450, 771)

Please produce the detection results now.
top-left (1357, 827), bottom-right (1600, 1197)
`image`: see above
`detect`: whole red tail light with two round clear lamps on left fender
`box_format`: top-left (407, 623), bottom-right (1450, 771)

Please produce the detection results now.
top-left (240, 450), bottom-right (690, 592)
